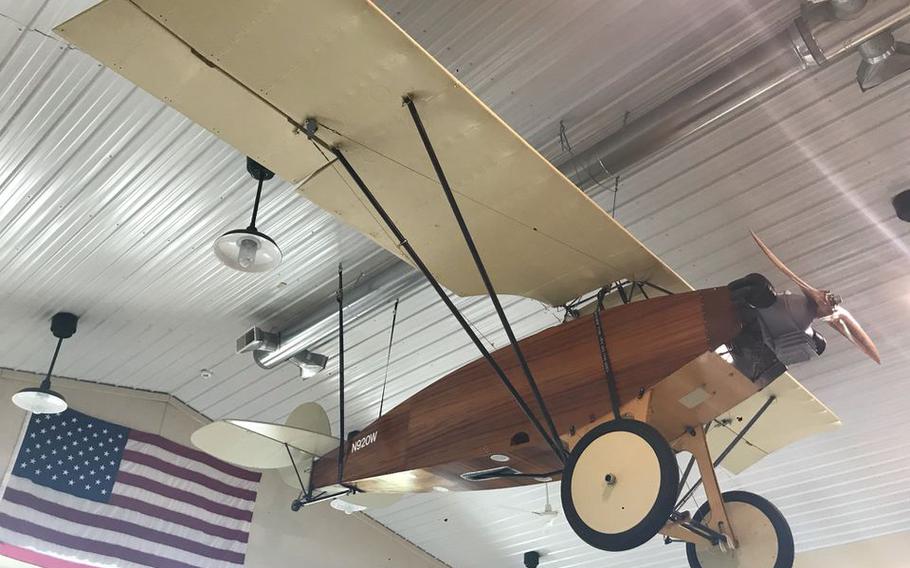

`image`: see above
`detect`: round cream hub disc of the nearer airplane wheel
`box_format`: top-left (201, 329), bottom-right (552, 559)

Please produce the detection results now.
top-left (571, 431), bottom-right (661, 534)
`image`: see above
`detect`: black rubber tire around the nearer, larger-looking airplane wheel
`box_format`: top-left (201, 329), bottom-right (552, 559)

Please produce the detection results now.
top-left (560, 418), bottom-right (679, 552)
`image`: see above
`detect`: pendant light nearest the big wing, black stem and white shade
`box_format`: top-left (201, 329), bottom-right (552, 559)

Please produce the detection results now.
top-left (214, 158), bottom-right (281, 272)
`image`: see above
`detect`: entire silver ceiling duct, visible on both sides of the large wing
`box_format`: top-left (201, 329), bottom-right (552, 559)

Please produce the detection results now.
top-left (238, 0), bottom-right (910, 369)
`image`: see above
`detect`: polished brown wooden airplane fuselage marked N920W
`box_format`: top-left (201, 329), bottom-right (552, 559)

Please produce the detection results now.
top-left (312, 288), bottom-right (741, 492)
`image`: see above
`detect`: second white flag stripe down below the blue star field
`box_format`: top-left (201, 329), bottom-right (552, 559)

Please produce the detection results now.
top-left (0, 501), bottom-right (242, 568)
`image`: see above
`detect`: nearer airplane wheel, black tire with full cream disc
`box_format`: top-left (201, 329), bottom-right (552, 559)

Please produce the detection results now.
top-left (561, 419), bottom-right (679, 551)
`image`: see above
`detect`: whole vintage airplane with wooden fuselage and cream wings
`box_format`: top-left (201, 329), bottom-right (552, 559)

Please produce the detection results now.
top-left (56, 0), bottom-right (878, 568)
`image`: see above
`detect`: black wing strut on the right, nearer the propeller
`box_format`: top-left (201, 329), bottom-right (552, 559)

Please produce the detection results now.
top-left (404, 97), bottom-right (559, 460)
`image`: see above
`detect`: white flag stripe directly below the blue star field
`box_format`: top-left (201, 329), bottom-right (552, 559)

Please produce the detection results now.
top-left (0, 475), bottom-right (246, 554)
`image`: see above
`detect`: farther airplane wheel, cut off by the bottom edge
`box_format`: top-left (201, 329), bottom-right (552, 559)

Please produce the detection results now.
top-left (686, 491), bottom-right (794, 568)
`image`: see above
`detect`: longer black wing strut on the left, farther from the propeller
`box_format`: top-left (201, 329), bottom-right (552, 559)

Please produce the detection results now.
top-left (304, 119), bottom-right (564, 462)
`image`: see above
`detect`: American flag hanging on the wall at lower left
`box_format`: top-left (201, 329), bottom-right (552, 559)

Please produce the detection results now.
top-left (0, 409), bottom-right (260, 568)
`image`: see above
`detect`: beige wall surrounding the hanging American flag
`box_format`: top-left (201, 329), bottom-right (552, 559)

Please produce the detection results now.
top-left (0, 369), bottom-right (445, 568)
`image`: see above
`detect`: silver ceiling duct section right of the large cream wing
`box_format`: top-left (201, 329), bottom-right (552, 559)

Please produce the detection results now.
top-left (559, 0), bottom-right (910, 193)
